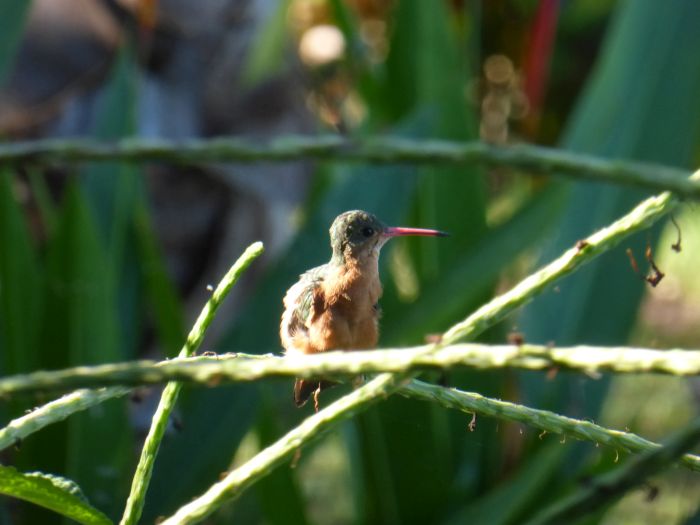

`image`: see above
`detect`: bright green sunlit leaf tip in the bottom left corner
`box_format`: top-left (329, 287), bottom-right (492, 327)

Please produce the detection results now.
top-left (0, 465), bottom-right (112, 525)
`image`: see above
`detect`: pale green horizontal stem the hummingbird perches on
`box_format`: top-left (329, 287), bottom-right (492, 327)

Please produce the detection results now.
top-left (0, 343), bottom-right (700, 396)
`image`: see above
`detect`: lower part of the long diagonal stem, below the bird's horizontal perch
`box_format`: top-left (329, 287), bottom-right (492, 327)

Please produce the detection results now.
top-left (160, 374), bottom-right (400, 525)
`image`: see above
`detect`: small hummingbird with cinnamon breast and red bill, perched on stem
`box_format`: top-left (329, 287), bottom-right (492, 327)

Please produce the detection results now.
top-left (280, 210), bottom-right (447, 411)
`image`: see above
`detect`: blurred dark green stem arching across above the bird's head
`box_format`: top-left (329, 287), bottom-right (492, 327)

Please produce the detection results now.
top-left (0, 135), bottom-right (700, 199)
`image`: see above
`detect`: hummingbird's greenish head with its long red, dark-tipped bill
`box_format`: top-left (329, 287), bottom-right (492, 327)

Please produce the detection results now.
top-left (330, 210), bottom-right (447, 262)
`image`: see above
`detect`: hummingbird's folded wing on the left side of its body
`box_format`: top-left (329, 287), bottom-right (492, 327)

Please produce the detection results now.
top-left (280, 266), bottom-right (325, 352)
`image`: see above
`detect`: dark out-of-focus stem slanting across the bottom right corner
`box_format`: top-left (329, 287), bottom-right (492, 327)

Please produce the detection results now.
top-left (527, 418), bottom-right (700, 525)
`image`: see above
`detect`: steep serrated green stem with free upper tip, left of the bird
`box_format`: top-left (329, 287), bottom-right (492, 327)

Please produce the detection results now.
top-left (120, 242), bottom-right (263, 525)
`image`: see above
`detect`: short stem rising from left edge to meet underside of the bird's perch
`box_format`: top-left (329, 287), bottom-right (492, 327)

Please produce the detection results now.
top-left (0, 387), bottom-right (131, 450)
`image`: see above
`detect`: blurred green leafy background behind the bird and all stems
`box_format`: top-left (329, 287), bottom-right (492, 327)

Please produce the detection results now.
top-left (0, 0), bottom-right (700, 525)
